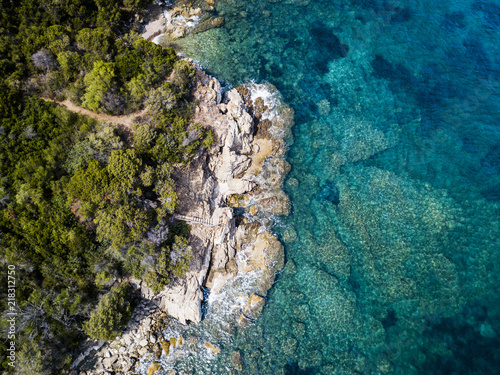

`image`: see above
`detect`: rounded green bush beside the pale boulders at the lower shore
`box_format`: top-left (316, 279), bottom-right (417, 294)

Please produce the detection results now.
top-left (83, 283), bottom-right (132, 340)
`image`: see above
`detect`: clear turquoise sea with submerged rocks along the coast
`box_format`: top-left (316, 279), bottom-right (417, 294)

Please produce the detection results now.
top-left (163, 0), bottom-right (500, 374)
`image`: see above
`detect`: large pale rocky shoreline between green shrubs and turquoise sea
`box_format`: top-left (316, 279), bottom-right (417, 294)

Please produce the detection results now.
top-left (72, 61), bottom-right (293, 375)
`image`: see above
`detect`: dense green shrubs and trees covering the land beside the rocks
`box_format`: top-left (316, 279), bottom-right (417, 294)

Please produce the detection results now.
top-left (0, 0), bottom-right (214, 374)
